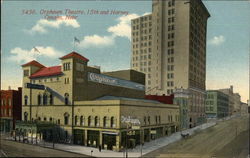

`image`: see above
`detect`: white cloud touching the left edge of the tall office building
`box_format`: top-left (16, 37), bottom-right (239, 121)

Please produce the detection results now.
top-left (108, 14), bottom-right (139, 39)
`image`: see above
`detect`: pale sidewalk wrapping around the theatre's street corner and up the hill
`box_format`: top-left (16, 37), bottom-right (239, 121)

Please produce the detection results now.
top-left (5, 120), bottom-right (218, 157)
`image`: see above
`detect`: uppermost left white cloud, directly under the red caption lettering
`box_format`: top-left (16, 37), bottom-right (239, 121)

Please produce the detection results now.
top-left (26, 16), bottom-right (80, 34)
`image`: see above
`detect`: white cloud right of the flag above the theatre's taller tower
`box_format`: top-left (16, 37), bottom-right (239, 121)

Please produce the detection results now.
top-left (77, 35), bottom-right (114, 48)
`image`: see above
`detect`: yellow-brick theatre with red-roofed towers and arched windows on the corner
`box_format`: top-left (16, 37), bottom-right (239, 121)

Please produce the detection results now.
top-left (16, 52), bottom-right (179, 151)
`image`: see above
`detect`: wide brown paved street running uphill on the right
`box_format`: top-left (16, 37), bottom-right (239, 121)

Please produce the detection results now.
top-left (144, 117), bottom-right (249, 158)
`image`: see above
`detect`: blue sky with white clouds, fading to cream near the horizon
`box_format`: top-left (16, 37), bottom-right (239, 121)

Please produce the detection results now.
top-left (1, 0), bottom-right (250, 102)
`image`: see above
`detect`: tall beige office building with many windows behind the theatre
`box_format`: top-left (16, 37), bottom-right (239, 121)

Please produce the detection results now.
top-left (131, 0), bottom-right (210, 127)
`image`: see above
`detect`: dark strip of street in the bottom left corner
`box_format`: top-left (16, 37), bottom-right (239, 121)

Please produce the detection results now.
top-left (0, 140), bottom-right (86, 157)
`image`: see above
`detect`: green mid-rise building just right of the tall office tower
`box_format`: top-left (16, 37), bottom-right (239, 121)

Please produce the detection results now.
top-left (206, 90), bottom-right (229, 118)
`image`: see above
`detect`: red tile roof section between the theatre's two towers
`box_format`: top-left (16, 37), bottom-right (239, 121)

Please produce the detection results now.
top-left (30, 66), bottom-right (62, 78)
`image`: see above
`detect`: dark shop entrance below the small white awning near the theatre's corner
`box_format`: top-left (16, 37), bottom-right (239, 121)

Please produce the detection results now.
top-left (102, 134), bottom-right (116, 150)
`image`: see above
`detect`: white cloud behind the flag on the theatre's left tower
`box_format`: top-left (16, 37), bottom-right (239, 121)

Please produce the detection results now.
top-left (9, 46), bottom-right (63, 63)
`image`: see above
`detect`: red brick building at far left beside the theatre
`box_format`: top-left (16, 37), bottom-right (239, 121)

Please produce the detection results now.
top-left (0, 88), bottom-right (22, 132)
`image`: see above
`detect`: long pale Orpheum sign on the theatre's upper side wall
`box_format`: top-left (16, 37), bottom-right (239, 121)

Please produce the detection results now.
top-left (88, 72), bottom-right (145, 91)
